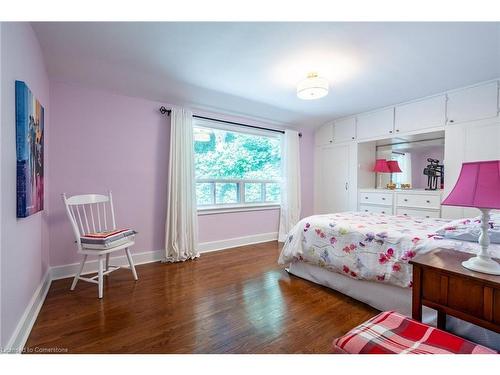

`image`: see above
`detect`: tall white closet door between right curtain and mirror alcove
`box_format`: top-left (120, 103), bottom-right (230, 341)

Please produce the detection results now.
top-left (317, 145), bottom-right (350, 214)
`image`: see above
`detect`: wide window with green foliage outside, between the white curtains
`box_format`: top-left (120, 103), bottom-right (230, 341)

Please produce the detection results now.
top-left (194, 120), bottom-right (281, 209)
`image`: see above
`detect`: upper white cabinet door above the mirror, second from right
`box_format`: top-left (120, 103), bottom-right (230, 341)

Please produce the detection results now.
top-left (394, 95), bottom-right (446, 133)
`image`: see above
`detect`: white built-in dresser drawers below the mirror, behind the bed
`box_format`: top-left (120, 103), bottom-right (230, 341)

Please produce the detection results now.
top-left (358, 189), bottom-right (442, 218)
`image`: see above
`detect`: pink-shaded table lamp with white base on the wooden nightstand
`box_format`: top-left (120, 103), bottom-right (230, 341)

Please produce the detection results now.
top-left (442, 160), bottom-right (500, 275)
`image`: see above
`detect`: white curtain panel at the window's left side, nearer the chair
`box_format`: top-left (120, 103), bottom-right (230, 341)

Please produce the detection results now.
top-left (164, 108), bottom-right (199, 262)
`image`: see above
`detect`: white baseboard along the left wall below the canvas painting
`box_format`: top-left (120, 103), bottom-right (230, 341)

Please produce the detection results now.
top-left (2, 268), bottom-right (52, 353)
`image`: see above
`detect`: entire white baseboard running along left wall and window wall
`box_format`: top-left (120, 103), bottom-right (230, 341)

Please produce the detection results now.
top-left (4, 232), bottom-right (278, 353)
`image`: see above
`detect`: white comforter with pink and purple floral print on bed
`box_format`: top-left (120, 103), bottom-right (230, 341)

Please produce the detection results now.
top-left (279, 212), bottom-right (500, 287)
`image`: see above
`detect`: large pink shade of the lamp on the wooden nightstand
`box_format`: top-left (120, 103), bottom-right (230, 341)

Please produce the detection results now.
top-left (442, 160), bottom-right (500, 209)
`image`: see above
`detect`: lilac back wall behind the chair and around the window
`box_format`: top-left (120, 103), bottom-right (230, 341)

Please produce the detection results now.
top-left (49, 83), bottom-right (313, 265)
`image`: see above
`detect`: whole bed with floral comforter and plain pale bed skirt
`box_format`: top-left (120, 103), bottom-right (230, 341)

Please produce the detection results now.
top-left (278, 212), bottom-right (500, 350)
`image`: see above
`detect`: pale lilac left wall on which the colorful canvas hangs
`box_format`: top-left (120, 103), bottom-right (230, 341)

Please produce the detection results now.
top-left (0, 22), bottom-right (51, 348)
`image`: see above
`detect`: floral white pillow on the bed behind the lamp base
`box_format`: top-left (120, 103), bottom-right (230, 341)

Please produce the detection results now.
top-left (436, 213), bottom-right (500, 243)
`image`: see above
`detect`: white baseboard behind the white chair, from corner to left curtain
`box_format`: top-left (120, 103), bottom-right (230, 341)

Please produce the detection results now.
top-left (50, 250), bottom-right (162, 280)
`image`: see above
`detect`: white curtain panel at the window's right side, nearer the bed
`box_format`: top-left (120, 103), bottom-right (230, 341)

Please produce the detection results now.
top-left (278, 130), bottom-right (300, 242)
